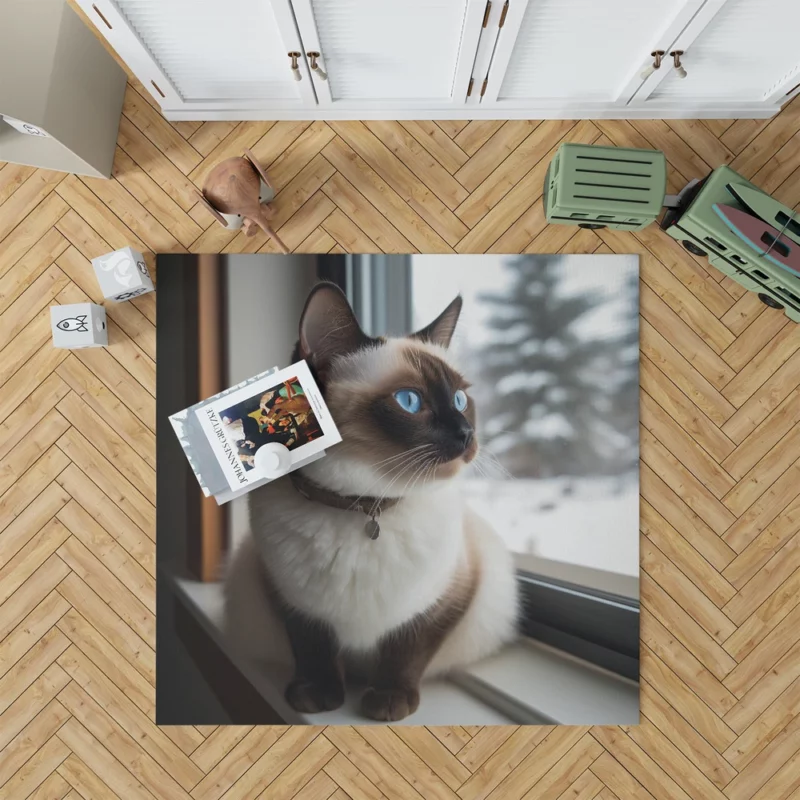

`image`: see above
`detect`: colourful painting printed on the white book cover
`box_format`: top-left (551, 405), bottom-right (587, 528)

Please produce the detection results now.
top-left (220, 378), bottom-right (323, 470)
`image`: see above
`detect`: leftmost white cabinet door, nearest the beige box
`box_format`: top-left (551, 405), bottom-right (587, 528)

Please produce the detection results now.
top-left (77, 0), bottom-right (316, 113)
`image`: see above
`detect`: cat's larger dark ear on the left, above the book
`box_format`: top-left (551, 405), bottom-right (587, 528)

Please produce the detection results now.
top-left (297, 283), bottom-right (372, 371)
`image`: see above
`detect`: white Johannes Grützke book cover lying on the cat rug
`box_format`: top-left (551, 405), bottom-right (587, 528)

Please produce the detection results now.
top-left (195, 361), bottom-right (342, 491)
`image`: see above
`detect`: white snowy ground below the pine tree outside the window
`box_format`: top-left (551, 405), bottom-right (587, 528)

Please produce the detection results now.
top-left (464, 478), bottom-right (639, 577)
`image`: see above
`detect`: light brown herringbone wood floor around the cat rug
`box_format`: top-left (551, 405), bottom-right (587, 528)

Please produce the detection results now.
top-left (0, 51), bottom-right (800, 800)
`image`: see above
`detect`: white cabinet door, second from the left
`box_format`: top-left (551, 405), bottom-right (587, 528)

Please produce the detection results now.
top-left (291, 0), bottom-right (486, 111)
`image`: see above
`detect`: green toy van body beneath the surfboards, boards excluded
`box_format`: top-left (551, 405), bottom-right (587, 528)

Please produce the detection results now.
top-left (661, 166), bottom-right (800, 322)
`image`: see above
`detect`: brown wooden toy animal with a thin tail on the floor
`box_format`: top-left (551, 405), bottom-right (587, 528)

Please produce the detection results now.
top-left (197, 150), bottom-right (289, 253)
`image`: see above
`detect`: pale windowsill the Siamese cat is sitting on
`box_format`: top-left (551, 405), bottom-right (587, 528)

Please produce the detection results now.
top-left (174, 578), bottom-right (639, 725)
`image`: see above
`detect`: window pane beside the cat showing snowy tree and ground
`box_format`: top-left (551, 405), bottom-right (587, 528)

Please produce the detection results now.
top-left (411, 255), bottom-right (639, 577)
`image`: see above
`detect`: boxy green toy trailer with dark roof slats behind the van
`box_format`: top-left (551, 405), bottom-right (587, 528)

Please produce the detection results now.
top-left (544, 144), bottom-right (667, 231)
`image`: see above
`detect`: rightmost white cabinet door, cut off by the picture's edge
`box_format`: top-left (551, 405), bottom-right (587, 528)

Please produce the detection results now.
top-left (632, 0), bottom-right (800, 109)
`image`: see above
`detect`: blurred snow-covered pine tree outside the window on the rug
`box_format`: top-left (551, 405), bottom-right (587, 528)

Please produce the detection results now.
top-left (479, 255), bottom-right (621, 478)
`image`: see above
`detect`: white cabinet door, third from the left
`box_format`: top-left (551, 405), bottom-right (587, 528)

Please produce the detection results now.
top-left (481, 0), bottom-right (703, 113)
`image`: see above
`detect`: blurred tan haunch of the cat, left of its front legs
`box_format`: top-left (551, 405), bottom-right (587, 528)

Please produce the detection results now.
top-left (223, 534), bottom-right (293, 664)
